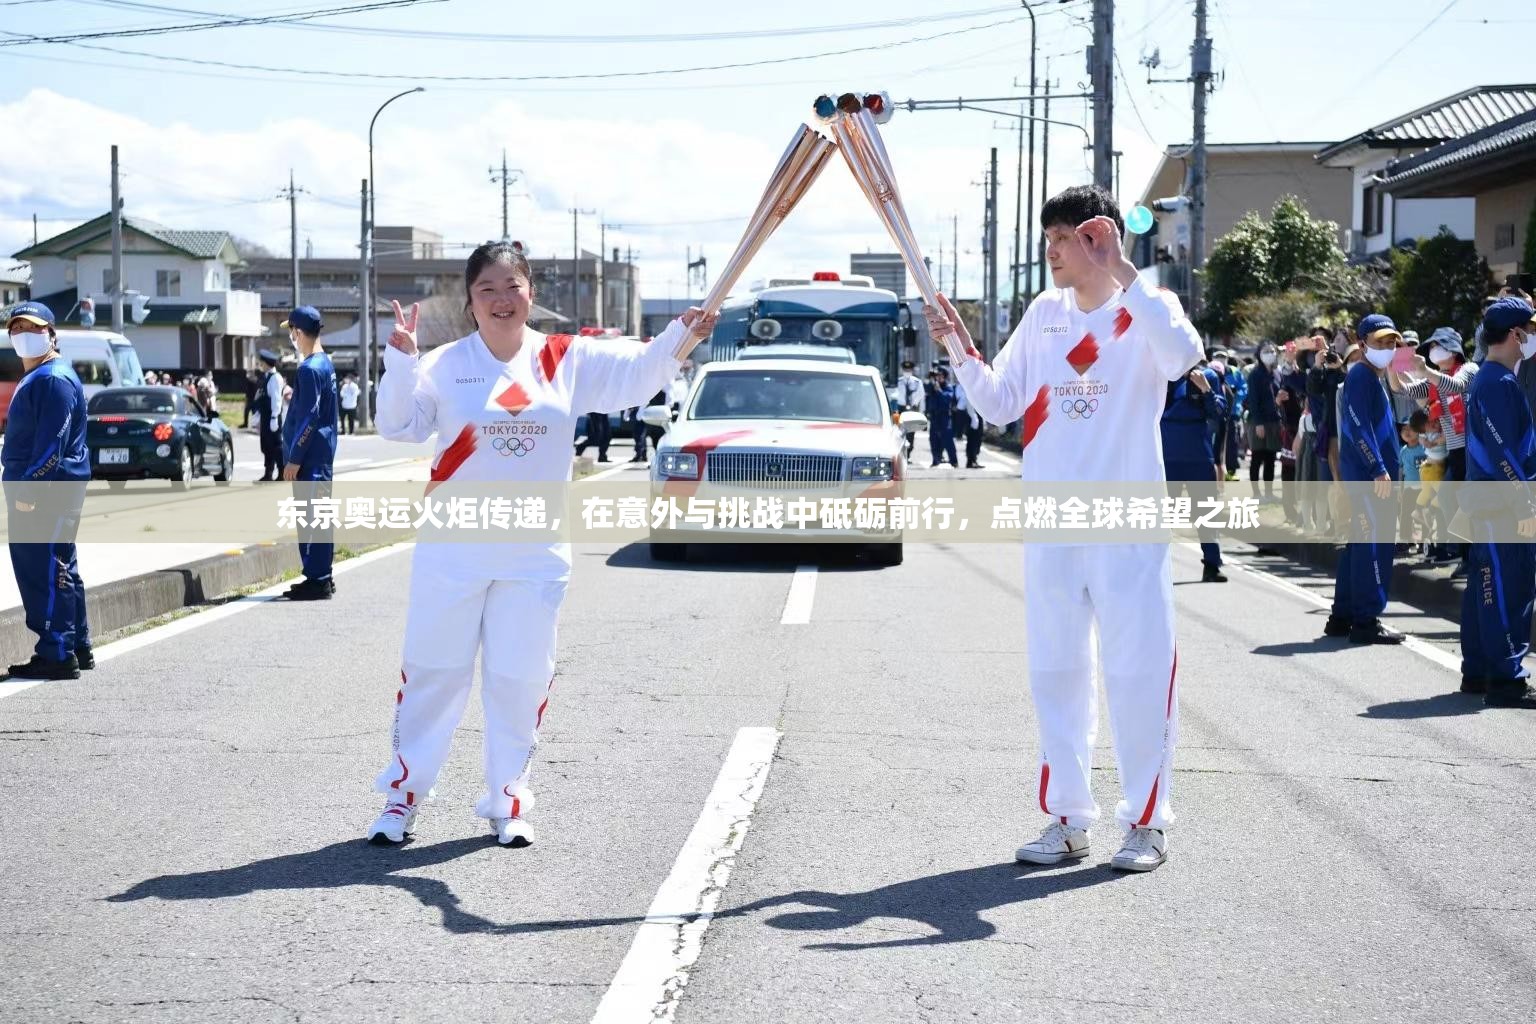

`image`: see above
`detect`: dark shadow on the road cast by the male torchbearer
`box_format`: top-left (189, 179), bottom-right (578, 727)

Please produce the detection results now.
top-left (719, 861), bottom-right (1121, 952)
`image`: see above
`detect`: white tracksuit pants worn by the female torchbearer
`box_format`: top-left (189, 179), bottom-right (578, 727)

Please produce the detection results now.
top-left (375, 564), bottom-right (565, 818)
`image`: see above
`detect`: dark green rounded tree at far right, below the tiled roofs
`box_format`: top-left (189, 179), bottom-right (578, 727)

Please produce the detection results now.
top-left (1387, 227), bottom-right (1493, 338)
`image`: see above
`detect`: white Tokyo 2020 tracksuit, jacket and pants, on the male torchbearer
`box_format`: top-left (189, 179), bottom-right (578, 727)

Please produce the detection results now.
top-left (955, 279), bottom-right (1203, 829)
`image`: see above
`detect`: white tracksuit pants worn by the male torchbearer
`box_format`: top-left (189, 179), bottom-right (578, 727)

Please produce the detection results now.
top-left (1025, 543), bottom-right (1178, 829)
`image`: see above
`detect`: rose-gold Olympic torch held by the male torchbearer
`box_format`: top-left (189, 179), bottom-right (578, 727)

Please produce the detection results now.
top-left (816, 92), bottom-right (974, 362)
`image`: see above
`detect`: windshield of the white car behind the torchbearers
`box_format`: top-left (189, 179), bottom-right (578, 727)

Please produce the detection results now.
top-left (688, 370), bottom-right (885, 424)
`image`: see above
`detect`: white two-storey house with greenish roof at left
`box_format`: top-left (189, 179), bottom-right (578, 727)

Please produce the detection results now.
top-left (14, 213), bottom-right (263, 370)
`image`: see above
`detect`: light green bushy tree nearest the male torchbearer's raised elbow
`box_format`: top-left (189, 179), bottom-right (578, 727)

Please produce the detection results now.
top-left (1197, 195), bottom-right (1344, 336)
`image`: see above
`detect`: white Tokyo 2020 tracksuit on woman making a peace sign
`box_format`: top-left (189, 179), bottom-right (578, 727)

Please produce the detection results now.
top-left (376, 321), bottom-right (687, 818)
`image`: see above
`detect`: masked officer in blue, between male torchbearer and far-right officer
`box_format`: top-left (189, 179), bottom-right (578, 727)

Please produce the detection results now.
top-left (1322, 313), bottom-right (1402, 643)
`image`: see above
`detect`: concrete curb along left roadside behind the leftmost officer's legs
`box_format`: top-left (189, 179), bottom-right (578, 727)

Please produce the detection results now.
top-left (0, 543), bottom-right (300, 665)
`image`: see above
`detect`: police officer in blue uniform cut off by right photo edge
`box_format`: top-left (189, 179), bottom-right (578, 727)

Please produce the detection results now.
top-left (1461, 296), bottom-right (1536, 708)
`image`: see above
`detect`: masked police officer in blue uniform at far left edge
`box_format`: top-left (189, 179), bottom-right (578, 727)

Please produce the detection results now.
top-left (0, 302), bottom-right (95, 679)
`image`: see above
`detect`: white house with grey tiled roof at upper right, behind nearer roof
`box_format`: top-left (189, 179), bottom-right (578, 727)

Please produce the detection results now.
top-left (1316, 84), bottom-right (1536, 259)
